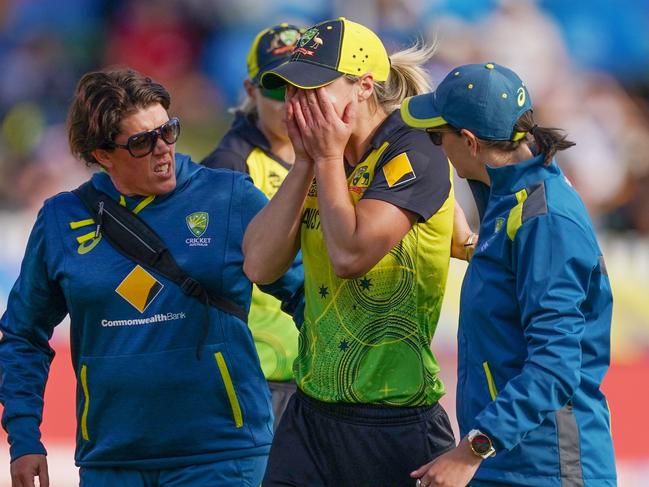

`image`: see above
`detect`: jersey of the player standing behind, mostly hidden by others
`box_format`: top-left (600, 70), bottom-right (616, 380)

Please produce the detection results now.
top-left (202, 113), bottom-right (299, 381)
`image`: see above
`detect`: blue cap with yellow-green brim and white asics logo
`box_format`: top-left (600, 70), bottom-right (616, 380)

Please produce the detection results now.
top-left (401, 63), bottom-right (532, 140)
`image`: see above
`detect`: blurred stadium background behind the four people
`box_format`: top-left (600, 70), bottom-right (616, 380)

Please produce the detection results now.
top-left (0, 0), bottom-right (649, 487)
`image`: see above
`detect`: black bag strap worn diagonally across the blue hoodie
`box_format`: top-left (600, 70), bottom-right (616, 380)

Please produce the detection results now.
top-left (72, 181), bottom-right (248, 322)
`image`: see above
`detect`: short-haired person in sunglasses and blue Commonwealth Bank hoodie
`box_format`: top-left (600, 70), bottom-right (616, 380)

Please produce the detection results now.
top-left (0, 70), bottom-right (302, 487)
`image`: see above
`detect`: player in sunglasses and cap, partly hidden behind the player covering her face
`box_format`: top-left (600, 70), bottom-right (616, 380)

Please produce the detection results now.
top-left (203, 23), bottom-right (301, 427)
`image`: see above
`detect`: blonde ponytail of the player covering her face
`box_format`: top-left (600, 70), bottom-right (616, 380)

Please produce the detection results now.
top-left (345, 42), bottom-right (437, 113)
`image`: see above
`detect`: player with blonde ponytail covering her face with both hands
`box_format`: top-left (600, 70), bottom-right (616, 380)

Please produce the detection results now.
top-left (244, 18), bottom-right (470, 487)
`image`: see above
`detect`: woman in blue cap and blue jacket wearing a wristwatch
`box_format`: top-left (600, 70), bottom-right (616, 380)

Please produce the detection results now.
top-left (401, 63), bottom-right (616, 487)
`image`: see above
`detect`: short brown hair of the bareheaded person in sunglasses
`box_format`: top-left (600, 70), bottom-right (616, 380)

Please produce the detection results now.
top-left (68, 69), bottom-right (171, 165)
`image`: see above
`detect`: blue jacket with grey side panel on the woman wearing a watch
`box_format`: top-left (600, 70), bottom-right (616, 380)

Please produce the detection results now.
top-left (457, 156), bottom-right (616, 487)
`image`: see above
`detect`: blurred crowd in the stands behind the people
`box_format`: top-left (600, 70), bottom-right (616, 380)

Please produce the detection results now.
top-left (0, 0), bottom-right (649, 235)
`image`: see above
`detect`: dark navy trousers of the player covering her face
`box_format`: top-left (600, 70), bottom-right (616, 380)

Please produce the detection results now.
top-left (262, 389), bottom-right (455, 487)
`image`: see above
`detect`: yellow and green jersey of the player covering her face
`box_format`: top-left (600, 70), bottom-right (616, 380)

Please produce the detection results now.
top-left (295, 111), bottom-right (454, 406)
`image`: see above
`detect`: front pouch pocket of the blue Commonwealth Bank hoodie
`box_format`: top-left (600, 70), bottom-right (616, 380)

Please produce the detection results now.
top-left (77, 344), bottom-right (258, 463)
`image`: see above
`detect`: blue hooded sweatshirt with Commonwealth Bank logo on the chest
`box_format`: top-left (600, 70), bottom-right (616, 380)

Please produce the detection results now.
top-left (0, 154), bottom-right (302, 468)
